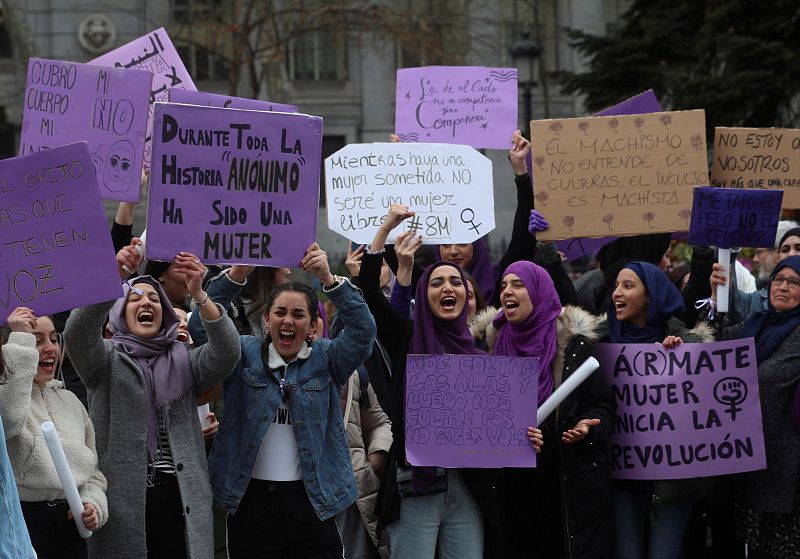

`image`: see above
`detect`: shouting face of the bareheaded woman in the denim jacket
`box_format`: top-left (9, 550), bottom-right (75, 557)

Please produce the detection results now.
top-left (267, 291), bottom-right (311, 361)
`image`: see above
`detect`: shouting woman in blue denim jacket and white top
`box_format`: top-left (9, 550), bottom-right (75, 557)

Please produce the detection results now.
top-left (198, 243), bottom-right (375, 558)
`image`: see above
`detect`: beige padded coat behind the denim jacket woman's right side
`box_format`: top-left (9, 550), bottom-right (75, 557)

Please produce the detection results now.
top-left (340, 372), bottom-right (392, 558)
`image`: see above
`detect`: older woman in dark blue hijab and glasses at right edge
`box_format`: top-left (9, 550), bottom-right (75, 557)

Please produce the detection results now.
top-left (723, 256), bottom-right (800, 559)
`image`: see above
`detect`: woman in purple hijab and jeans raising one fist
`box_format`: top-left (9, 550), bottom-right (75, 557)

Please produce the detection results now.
top-left (359, 205), bottom-right (497, 559)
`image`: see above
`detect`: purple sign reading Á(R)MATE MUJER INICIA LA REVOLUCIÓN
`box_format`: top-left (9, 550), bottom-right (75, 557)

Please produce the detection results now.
top-left (596, 338), bottom-right (767, 480)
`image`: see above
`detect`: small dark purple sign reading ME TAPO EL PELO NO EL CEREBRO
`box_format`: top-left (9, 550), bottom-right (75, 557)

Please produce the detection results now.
top-left (688, 187), bottom-right (783, 248)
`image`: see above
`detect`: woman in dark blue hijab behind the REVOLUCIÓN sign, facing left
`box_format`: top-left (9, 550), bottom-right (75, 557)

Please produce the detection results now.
top-left (603, 262), bottom-right (713, 559)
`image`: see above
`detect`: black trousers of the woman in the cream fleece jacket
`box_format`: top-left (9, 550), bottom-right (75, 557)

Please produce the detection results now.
top-left (21, 501), bottom-right (87, 559)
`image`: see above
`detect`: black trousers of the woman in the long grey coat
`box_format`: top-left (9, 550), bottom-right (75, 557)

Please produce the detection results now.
top-left (145, 472), bottom-right (186, 559)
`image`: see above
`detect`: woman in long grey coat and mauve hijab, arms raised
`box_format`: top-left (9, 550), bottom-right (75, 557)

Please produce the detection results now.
top-left (64, 247), bottom-right (240, 559)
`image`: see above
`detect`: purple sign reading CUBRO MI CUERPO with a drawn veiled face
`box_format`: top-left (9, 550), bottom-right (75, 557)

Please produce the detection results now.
top-left (19, 58), bottom-right (153, 202)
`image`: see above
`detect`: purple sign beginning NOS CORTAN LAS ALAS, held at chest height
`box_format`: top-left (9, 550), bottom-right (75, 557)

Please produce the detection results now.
top-left (405, 355), bottom-right (539, 468)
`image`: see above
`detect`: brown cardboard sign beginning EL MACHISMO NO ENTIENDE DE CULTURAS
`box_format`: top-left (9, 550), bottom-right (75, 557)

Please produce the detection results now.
top-left (531, 110), bottom-right (708, 241)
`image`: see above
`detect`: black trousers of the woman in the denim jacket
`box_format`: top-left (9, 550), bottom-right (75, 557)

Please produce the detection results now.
top-left (228, 479), bottom-right (342, 559)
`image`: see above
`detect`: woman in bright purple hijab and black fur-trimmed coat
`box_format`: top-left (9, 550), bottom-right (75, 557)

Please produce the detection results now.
top-left (472, 261), bottom-right (615, 558)
